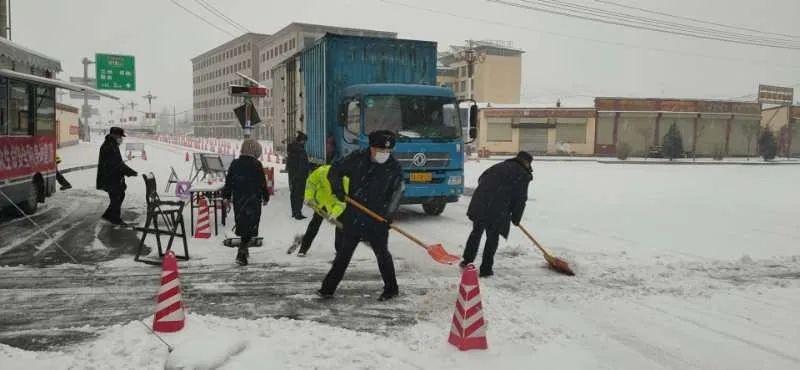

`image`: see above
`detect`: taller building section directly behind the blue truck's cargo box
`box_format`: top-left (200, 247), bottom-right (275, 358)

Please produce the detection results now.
top-left (257, 23), bottom-right (397, 142)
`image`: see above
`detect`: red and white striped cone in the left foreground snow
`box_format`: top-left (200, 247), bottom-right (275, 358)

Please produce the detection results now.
top-left (153, 250), bottom-right (186, 333)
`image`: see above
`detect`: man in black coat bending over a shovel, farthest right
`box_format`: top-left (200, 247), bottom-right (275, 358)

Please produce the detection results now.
top-left (461, 152), bottom-right (533, 277)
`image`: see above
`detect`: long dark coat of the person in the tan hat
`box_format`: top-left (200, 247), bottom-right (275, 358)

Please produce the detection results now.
top-left (222, 155), bottom-right (269, 238)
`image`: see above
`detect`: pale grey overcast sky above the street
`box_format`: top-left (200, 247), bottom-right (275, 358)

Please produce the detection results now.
top-left (11, 0), bottom-right (800, 115)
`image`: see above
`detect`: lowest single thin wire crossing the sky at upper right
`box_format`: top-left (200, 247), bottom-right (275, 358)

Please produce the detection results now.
top-left (378, 0), bottom-right (800, 69)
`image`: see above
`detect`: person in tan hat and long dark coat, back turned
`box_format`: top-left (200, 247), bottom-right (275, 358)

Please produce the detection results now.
top-left (222, 139), bottom-right (269, 266)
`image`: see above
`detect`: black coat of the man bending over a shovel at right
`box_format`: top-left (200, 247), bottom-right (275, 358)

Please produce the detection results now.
top-left (467, 158), bottom-right (533, 238)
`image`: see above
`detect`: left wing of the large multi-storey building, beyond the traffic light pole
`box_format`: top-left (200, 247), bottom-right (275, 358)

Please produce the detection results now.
top-left (191, 33), bottom-right (269, 138)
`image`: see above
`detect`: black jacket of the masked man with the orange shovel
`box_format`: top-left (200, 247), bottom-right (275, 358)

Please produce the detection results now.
top-left (328, 149), bottom-right (403, 236)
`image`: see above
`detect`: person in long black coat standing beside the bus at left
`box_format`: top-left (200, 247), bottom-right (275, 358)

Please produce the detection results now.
top-left (96, 127), bottom-right (136, 225)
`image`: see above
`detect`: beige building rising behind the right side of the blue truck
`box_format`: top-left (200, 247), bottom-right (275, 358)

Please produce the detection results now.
top-left (436, 40), bottom-right (524, 104)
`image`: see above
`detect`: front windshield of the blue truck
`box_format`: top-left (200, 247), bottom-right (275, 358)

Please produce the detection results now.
top-left (364, 95), bottom-right (461, 140)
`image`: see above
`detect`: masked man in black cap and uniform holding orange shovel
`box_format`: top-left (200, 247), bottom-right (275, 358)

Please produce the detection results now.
top-left (317, 130), bottom-right (403, 301)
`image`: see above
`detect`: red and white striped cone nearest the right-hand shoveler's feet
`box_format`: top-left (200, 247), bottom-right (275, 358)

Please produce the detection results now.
top-left (447, 264), bottom-right (488, 351)
